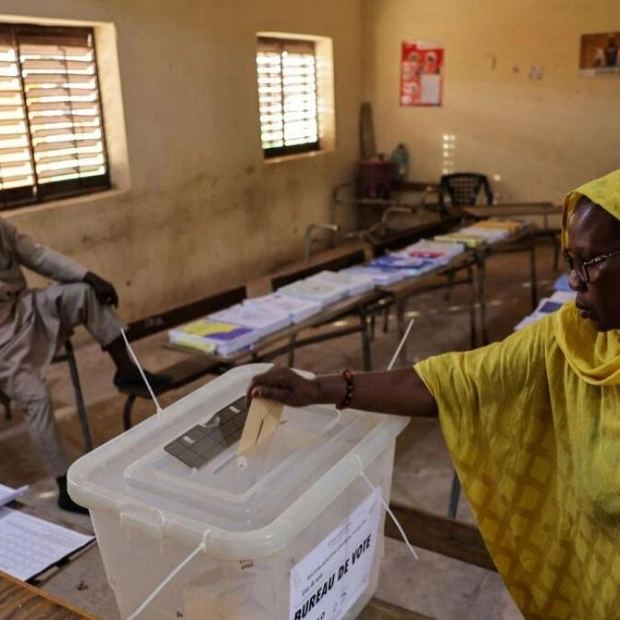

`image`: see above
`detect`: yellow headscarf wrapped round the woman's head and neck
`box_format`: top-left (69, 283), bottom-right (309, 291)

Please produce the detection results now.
top-left (555, 170), bottom-right (620, 385)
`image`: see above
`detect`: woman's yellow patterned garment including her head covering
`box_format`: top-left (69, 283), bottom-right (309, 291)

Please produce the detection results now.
top-left (415, 172), bottom-right (620, 620)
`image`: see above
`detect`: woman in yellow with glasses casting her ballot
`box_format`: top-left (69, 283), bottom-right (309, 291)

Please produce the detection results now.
top-left (248, 170), bottom-right (620, 620)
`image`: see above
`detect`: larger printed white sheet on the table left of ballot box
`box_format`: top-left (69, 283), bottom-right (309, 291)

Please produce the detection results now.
top-left (0, 508), bottom-right (94, 581)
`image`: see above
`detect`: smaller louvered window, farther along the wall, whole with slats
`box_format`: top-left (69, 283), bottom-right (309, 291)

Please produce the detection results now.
top-left (256, 37), bottom-right (320, 157)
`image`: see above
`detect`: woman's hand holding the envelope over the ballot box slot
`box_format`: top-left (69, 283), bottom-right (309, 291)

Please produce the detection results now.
top-left (246, 366), bottom-right (321, 407)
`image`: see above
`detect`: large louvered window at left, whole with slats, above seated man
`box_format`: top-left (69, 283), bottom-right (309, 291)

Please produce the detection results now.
top-left (0, 24), bottom-right (110, 209)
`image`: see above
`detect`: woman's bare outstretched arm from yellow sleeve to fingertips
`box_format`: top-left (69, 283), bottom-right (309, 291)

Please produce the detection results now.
top-left (247, 366), bottom-right (437, 417)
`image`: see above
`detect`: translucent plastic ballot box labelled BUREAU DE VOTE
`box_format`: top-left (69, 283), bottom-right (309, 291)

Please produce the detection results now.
top-left (68, 364), bottom-right (407, 620)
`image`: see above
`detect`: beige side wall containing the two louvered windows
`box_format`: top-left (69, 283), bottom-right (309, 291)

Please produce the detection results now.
top-left (0, 0), bottom-right (361, 320)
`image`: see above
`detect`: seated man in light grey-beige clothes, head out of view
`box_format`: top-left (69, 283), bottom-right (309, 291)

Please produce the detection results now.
top-left (0, 218), bottom-right (170, 512)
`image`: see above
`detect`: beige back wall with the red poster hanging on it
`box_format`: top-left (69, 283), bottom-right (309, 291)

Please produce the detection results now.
top-left (363, 0), bottom-right (620, 202)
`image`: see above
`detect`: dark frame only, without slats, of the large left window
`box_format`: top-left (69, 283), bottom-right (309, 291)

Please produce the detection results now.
top-left (0, 22), bottom-right (112, 211)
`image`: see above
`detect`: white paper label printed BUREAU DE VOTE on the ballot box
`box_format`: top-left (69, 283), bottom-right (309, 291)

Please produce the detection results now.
top-left (289, 489), bottom-right (381, 620)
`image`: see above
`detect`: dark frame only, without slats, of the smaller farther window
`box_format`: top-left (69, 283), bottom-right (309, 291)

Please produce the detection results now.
top-left (256, 34), bottom-right (323, 160)
